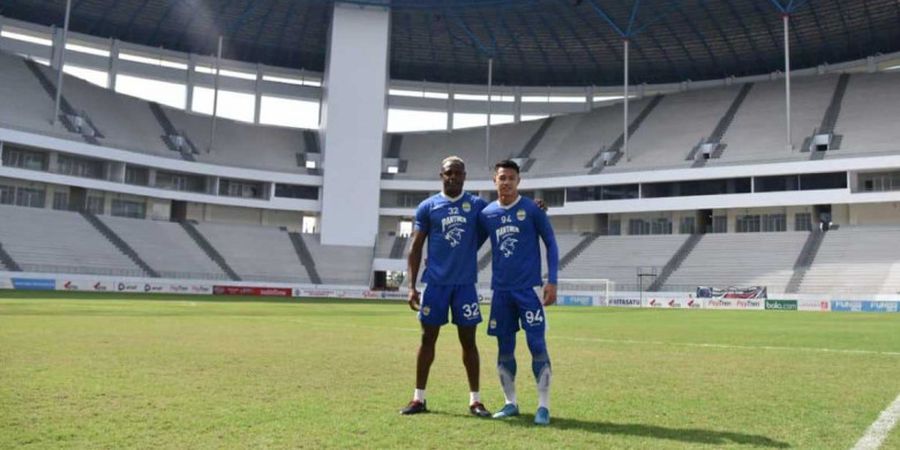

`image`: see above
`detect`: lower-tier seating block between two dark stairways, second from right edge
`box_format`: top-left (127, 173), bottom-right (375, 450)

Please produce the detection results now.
top-left (661, 231), bottom-right (809, 292)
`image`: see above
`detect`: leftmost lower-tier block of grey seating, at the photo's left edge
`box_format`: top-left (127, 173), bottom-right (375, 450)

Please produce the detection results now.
top-left (0, 206), bottom-right (146, 276)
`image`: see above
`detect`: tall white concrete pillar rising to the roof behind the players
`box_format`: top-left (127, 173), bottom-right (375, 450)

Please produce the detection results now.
top-left (322, 2), bottom-right (391, 247)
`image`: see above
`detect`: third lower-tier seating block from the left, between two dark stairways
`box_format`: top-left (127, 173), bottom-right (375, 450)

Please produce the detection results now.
top-left (196, 222), bottom-right (309, 283)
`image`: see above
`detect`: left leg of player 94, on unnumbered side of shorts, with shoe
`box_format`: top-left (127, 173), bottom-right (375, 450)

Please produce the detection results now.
top-left (488, 291), bottom-right (519, 418)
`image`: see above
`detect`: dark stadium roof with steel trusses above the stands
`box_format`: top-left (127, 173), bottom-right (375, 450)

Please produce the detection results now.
top-left (0, 0), bottom-right (900, 86)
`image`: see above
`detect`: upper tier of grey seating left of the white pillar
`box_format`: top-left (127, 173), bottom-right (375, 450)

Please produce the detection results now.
top-left (0, 53), bottom-right (319, 173)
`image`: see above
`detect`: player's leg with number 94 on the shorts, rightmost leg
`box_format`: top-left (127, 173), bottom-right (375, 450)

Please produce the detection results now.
top-left (515, 289), bottom-right (553, 425)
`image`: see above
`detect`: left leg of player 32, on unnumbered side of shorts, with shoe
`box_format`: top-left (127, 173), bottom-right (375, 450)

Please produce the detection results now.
top-left (400, 286), bottom-right (450, 414)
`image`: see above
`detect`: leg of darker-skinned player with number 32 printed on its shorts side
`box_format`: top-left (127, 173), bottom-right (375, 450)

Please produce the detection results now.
top-left (450, 285), bottom-right (491, 417)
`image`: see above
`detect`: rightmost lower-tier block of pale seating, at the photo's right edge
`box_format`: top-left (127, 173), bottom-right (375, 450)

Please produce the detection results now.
top-left (800, 226), bottom-right (900, 294)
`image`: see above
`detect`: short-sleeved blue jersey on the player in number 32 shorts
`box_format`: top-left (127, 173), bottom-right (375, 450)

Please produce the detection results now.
top-left (415, 192), bottom-right (487, 285)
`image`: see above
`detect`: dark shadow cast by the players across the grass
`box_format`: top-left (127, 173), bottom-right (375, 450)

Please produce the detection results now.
top-left (436, 411), bottom-right (791, 448)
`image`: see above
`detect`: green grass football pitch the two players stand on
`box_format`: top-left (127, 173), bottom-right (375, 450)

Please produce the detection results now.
top-left (0, 292), bottom-right (900, 449)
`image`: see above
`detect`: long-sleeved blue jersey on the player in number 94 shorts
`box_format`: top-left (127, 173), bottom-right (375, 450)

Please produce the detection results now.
top-left (478, 197), bottom-right (559, 291)
